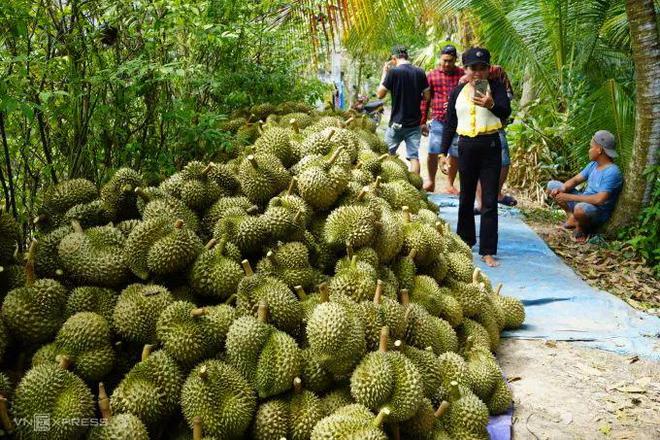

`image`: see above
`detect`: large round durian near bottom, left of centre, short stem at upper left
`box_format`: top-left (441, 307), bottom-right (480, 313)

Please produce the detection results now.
top-left (181, 359), bottom-right (257, 438)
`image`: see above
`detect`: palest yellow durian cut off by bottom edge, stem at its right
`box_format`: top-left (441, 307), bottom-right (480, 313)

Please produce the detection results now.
top-left (310, 403), bottom-right (390, 440)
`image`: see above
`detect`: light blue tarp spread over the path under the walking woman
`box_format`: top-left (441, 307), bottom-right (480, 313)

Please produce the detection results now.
top-left (429, 194), bottom-right (660, 440)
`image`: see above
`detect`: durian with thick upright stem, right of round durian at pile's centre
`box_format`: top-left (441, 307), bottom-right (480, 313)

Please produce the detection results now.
top-left (358, 280), bottom-right (406, 351)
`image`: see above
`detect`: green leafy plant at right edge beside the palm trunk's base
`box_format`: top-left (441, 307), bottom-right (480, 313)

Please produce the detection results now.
top-left (619, 165), bottom-right (660, 277)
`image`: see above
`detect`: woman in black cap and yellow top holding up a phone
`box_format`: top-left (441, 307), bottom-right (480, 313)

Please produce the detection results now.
top-left (440, 47), bottom-right (511, 267)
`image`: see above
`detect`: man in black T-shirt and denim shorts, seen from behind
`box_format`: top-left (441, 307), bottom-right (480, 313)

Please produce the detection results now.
top-left (376, 46), bottom-right (431, 174)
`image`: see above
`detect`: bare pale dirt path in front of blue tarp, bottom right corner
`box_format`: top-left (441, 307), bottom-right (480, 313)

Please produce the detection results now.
top-left (497, 339), bottom-right (660, 440)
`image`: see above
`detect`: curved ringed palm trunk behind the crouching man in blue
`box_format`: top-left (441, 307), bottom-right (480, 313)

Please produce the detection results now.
top-left (607, 0), bottom-right (660, 234)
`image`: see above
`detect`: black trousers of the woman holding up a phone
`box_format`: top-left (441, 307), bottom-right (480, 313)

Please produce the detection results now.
top-left (456, 133), bottom-right (502, 255)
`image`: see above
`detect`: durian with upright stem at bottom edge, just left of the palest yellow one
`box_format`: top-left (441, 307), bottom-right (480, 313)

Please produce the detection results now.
top-left (252, 377), bottom-right (324, 440)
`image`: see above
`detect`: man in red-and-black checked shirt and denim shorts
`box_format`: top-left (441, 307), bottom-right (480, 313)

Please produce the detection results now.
top-left (420, 44), bottom-right (465, 194)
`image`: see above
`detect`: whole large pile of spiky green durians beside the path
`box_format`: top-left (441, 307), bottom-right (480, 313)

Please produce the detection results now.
top-left (0, 105), bottom-right (524, 440)
